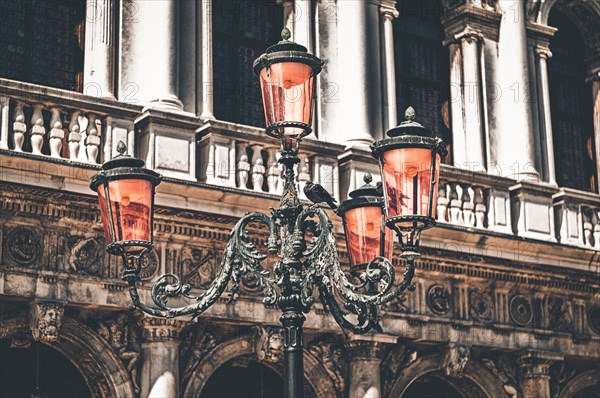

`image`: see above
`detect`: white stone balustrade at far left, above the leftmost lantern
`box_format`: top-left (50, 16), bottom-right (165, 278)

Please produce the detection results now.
top-left (0, 79), bottom-right (141, 164)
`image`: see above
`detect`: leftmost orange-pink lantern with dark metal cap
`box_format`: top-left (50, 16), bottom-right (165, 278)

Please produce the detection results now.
top-left (90, 142), bottom-right (161, 258)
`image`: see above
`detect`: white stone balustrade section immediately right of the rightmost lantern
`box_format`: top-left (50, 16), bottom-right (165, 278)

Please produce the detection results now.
top-left (436, 165), bottom-right (513, 233)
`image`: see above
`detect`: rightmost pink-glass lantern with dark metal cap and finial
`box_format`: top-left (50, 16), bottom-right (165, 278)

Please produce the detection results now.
top-left (371, 107), bottom-right (446, 235)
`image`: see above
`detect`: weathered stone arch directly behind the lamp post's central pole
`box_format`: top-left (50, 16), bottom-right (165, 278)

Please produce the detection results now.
top-left (183, 334), bottom-right (337, 398)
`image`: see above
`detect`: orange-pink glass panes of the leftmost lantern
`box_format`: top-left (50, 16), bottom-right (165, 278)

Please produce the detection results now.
top-left (98, 179), bottom-right (154, 255)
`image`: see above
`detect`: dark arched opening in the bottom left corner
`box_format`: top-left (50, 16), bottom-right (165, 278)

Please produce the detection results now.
top-left (0, 341), bottom-right (92, 398)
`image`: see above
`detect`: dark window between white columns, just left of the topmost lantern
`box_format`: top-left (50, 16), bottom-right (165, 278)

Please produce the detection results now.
top-left (213, 0), bottom-right (283, 127)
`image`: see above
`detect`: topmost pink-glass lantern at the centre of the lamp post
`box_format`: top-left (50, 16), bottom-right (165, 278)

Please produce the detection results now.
top-left (254, 28), bottom-right (323, 149)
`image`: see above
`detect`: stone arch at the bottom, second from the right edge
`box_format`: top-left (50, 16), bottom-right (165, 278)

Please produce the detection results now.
top-left (388, 355), bottom-right (506, 398)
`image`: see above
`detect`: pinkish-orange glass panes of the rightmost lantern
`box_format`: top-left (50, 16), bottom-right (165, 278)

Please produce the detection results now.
top-left (382, 148), bottom-right (440, 227)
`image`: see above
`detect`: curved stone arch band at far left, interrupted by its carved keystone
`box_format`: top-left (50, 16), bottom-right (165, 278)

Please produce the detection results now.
top-left (0, 316), bottom-right (135, 398)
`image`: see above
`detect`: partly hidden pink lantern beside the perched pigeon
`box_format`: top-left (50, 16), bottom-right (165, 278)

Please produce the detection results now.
top-left (338, 174), bottom-right (394, 269)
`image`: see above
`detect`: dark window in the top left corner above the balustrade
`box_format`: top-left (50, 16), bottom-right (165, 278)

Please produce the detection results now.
top-left (0, 0), bottom-right (85, 91)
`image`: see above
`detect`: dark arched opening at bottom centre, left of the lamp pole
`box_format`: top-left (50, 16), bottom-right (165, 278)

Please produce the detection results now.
top-left (200, 358), bottom-right (283, 398)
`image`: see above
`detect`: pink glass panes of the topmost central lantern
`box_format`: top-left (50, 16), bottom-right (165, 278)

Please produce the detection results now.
top-left (260, 62), bottom-right (314, 137)
